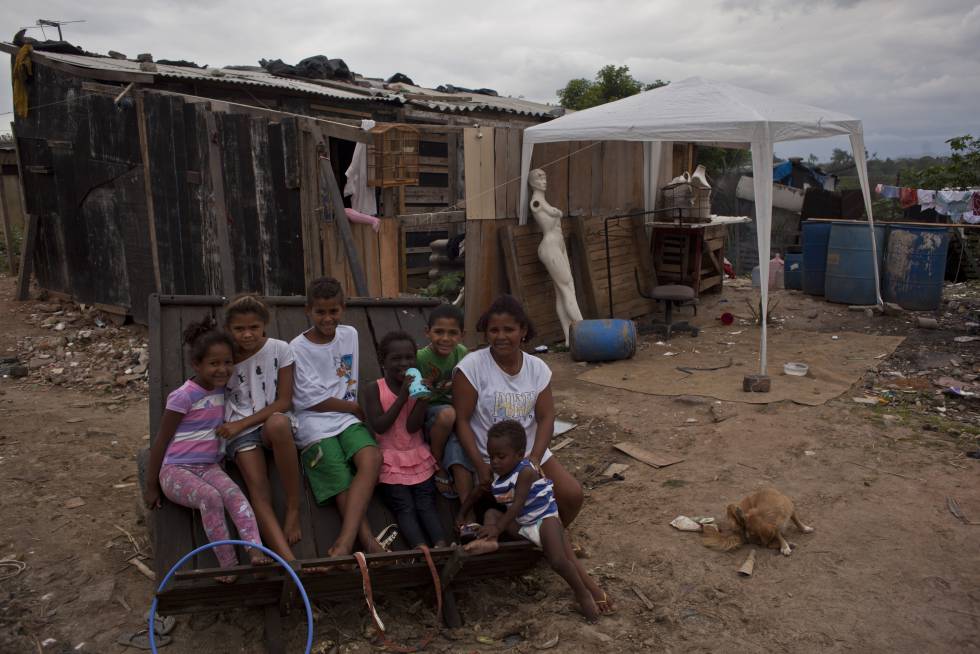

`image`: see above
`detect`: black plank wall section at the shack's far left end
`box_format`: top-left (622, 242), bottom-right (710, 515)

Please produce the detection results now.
top-left (14, 65), bottom-right (155, 321)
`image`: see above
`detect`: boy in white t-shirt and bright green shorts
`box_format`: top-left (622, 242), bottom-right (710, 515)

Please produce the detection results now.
top-left (290, 277), bottom-right (383, 556)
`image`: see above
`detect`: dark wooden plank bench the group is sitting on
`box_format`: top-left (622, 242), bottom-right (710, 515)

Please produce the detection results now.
top-left (137, 295), bottom-right (540, 653)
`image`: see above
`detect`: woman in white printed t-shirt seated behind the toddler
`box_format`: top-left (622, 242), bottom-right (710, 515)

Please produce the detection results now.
top-left (453, 295), bottom-right (584, 526)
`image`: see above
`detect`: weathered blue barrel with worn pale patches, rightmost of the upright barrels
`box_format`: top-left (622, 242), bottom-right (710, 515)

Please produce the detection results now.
top-left (881, 225), bottom-right (949, 311)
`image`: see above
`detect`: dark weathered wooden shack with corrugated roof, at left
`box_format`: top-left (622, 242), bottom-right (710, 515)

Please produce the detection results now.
top-left (0, 43), bottom-right (560, 322)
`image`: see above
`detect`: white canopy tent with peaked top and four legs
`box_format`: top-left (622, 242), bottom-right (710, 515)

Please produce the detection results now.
top-left (519, 77), bottom-right (882, 375)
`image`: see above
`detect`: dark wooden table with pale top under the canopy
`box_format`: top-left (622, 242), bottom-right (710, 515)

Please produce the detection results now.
top-left (650, 216), bottom-right (751, 296)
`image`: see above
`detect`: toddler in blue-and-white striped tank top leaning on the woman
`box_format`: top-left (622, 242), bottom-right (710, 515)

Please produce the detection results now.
top-left (457, 420), bottom-right (609, 622)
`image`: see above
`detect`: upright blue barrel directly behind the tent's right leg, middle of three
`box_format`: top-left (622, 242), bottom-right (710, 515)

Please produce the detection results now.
top-left (824, 221), bottom-right (885, 305)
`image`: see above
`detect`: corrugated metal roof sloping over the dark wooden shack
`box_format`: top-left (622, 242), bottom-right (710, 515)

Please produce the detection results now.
top-left (15, 44), bottom-right (565, 118)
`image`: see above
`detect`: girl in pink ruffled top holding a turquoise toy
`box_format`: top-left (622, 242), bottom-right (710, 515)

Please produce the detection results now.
top-left (364, 332), bottom-right (446, 548)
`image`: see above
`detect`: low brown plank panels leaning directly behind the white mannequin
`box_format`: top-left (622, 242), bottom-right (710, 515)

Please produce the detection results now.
top-left (500, 216), bottom-right (654, 345)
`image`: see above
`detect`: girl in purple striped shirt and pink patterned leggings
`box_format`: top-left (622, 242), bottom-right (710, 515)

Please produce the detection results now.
top-left (144, 319), bottom-right (271, 582)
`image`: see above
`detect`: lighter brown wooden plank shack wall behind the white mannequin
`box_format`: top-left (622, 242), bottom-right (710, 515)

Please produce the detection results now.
top-left (463, 127), bottom-right (694, 344)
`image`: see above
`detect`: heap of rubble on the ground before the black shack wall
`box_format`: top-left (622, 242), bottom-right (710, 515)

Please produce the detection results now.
top-left (0, 302), bottom-right (150, 394)
